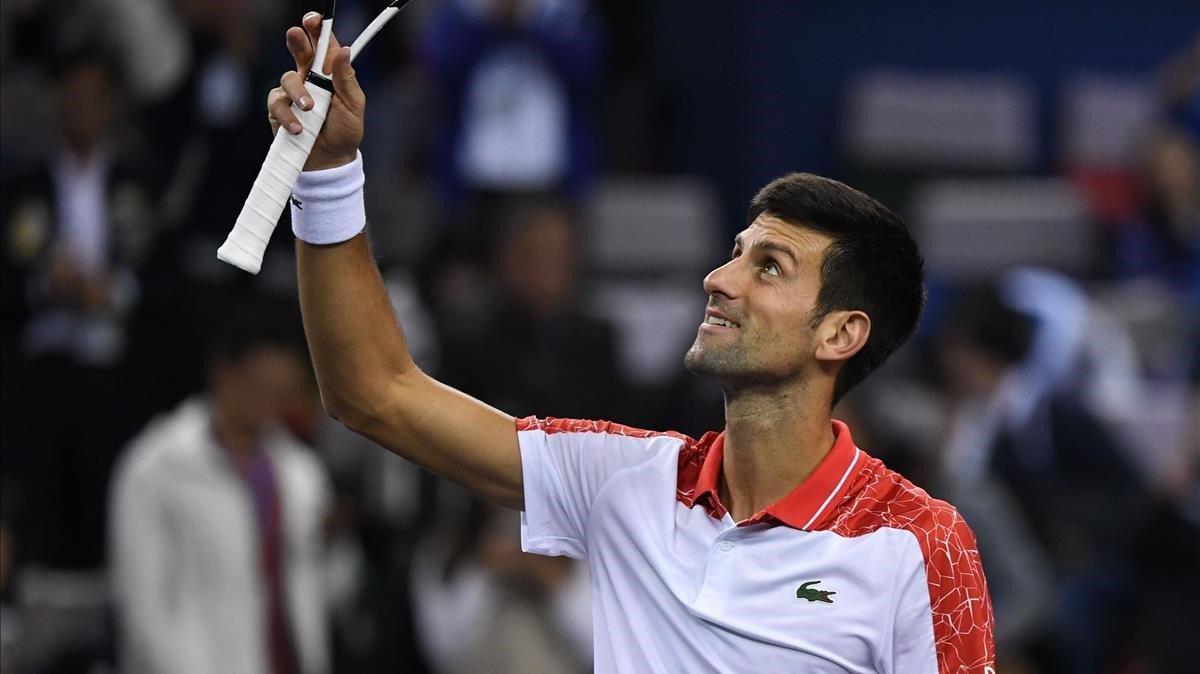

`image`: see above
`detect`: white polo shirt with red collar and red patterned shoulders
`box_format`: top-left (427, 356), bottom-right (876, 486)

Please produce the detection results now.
top-left (517, 417), bottom-right (995, 674)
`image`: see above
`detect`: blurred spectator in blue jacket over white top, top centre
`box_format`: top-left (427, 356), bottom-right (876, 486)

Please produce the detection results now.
top-left (427, 0), bottom-right (600, 204)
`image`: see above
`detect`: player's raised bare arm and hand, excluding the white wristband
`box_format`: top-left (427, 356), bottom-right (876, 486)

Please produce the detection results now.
top-left (268, 14), bottom-right (523, 508)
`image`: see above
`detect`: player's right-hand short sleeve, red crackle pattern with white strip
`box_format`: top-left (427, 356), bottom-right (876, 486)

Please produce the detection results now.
top-left (893, 507), bottom-right (996, 674)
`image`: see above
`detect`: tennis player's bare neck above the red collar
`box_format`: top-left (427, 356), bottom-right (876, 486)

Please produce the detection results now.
top-left (720, 386), bottom-right (834, 522)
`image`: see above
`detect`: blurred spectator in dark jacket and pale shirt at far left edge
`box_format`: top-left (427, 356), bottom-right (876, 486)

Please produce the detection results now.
top-left (5, 52), bottom-right (155, 366)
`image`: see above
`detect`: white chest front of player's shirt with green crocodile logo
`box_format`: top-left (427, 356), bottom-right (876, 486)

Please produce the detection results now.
top-left (588, 465), bottom-right (920, 672)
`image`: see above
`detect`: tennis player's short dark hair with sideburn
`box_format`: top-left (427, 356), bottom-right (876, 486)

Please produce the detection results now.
top-left (746, 173), bottom-right (925, 404)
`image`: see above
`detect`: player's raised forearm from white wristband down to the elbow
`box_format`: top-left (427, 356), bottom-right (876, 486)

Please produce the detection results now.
top-left (296, 233), bottom-right (416, 419)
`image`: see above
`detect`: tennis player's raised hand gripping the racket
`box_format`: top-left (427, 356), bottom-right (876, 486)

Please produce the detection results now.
top-left (266, 12), bottom-right (367, 170)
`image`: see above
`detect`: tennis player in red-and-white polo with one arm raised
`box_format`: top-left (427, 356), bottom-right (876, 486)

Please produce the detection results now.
top-left (269, 16), bottom-right (995, 674)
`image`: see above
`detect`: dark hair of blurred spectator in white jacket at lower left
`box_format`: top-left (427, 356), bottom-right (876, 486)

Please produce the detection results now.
top-left (208, 297), bottom-right (307, 363)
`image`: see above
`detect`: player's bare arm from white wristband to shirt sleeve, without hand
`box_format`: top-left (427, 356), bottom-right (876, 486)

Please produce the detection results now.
top-left (296, 234), bottom-right (524, 508)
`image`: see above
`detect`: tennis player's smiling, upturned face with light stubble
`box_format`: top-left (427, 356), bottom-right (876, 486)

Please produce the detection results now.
top-left (684, 215), bottom-right (833, 385)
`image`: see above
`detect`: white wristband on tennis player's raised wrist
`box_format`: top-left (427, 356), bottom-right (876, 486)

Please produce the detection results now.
top-left (292, 152), bottom-right (367, 243)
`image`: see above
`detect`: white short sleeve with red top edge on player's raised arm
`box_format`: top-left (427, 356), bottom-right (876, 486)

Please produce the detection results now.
top-left (516, 417), bottom-right (688, 559)
